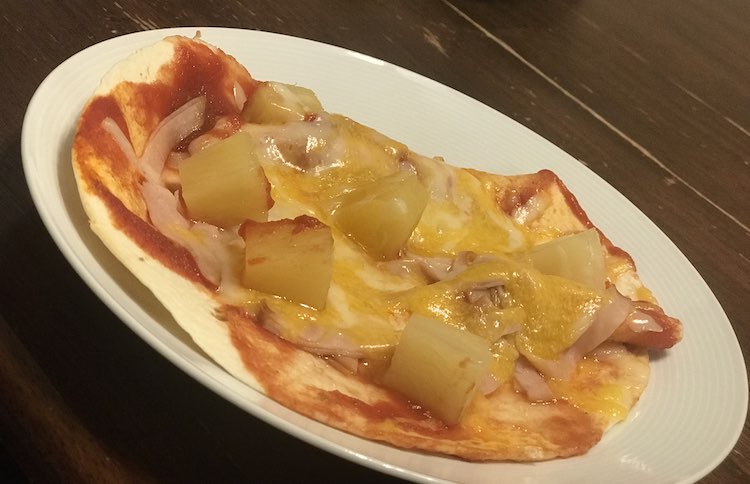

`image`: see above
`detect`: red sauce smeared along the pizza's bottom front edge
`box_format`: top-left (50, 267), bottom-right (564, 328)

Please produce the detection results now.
top-left (218, 306), bottom-right (602, 460)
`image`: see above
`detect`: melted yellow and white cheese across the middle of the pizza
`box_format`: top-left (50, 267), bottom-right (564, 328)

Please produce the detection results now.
top-left (212, 114), bottom-right (603, 381)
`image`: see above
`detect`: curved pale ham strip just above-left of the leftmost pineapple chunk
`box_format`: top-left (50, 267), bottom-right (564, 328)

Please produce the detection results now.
top-left (138, 96), bottom-right (206, 183)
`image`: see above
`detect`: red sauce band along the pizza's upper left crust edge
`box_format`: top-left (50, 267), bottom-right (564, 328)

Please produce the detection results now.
top-left (73, 39), bottom-right (257, 288)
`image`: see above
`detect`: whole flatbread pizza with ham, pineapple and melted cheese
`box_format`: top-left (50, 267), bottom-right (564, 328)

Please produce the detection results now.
top-left (72, 35), bottom-right (682, 461)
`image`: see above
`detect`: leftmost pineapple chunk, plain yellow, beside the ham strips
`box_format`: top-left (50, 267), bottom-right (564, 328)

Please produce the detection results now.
top-left (179, 132), bottom-right (273, 228)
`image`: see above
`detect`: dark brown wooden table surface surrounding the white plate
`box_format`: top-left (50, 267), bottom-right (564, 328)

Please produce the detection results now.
top-left (0, 0), bottom-right (750, 483)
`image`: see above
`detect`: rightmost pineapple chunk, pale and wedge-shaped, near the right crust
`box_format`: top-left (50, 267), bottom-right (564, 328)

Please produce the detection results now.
top-left (529, 228), bottom-right (607, 290)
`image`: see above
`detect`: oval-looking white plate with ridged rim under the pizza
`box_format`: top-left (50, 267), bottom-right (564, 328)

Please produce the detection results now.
top-left (22, 28), bottom-right (748, 483)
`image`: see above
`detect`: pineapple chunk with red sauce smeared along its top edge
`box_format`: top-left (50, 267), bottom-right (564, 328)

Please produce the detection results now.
top-left (240, 215), bottom-right (333, 309)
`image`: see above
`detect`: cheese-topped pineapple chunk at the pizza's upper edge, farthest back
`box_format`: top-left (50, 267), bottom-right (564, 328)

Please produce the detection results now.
top-left (242, 82), bottom-right (323, 124)
